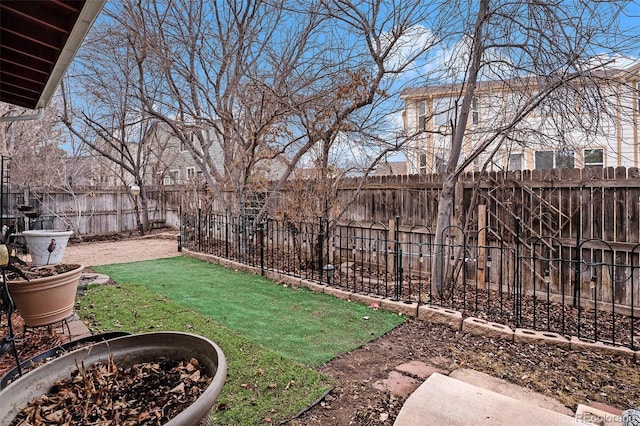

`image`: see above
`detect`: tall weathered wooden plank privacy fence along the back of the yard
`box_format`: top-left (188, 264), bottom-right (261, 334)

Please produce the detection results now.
top-left (3, 168), bottom-right (640, 241)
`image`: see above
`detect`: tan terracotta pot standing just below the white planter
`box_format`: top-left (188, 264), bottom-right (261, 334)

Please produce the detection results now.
top-left (7, 265), bottom-right (84, 327)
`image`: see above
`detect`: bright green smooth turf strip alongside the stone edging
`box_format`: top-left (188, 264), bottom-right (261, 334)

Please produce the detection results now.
top-left (94, 257), bottom-right (404, 367)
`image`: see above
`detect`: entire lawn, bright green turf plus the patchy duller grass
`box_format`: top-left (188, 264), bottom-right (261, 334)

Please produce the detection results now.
top-left (77, 257), bottom-right (404, 425)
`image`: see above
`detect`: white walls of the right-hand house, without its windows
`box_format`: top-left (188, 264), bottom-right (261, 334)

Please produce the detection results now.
top-left (404, 70), bottom-right (639, 173)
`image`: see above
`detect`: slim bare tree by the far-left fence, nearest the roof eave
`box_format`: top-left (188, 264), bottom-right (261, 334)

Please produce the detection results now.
top-left (61, 10), bottom-right (180, 232)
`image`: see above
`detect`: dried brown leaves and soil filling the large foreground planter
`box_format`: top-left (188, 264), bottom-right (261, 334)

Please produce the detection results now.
top-left (11, 358), bottom-right (211, 426)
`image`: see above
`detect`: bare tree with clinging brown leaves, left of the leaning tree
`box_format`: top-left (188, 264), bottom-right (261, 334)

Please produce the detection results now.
top-left (254, 1), bottom-right (453, 223)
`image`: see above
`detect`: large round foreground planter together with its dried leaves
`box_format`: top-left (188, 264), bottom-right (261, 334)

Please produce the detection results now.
top-left (0, 332), bottom-right (227, 425)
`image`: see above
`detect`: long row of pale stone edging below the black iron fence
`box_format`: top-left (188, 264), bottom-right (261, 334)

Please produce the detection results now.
top-left (182, 248), bottom-right (640, 361)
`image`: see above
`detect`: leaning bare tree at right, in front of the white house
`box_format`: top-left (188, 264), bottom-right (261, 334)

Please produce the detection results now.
top-left (404, 0), bottom-right (628, 292)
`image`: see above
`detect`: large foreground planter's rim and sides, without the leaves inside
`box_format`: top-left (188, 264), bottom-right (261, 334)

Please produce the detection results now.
top-left (0, 332), bottom-right (227, 426)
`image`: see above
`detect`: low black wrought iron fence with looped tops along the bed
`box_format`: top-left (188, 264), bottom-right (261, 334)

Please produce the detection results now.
top-left (181, 211), bottom-right (640, 350)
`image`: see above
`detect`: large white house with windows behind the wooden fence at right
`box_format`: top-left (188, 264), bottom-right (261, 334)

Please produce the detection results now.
top-left (401, 65), bottom-right (640, 173)
